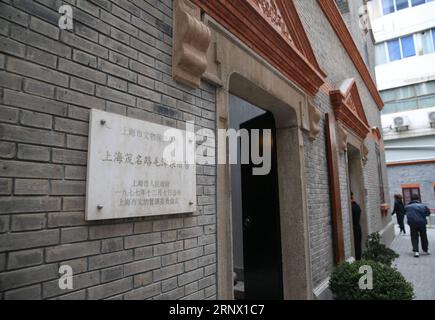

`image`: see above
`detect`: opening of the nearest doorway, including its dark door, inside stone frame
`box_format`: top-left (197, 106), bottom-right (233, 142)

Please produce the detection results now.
top-left (230, 95), bottom-right (283, 300)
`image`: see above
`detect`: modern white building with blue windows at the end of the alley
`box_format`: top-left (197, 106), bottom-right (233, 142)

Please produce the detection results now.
top-left (369, 0), bottom-right (435, 208)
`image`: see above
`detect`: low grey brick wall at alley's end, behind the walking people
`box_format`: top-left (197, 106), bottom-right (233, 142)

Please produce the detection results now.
top-left (387, 163), bottom-right (435, 209)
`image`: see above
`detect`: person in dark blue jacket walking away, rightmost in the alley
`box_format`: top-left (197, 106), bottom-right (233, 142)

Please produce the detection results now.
top-left (405, 194), bottom-right (430, 258)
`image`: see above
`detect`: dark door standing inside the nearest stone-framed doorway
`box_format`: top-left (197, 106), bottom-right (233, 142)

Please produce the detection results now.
top-left (240, 113), bottom-right (283, 300)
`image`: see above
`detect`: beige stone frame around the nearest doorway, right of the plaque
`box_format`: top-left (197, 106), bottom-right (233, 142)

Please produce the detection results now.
top-left (204, 16), bottom-right (313, 299)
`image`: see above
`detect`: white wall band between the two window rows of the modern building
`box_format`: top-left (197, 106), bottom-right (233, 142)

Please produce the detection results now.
top-left (375, 52), bottom-right (435, 91)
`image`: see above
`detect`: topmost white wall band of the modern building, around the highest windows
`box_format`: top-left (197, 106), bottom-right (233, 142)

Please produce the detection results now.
top-left (368, 0), bottom-right (435, 43)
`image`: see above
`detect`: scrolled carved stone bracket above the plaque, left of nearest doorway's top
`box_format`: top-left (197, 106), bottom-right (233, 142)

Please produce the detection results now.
top-left (172, 0), bottom-right (211, 88)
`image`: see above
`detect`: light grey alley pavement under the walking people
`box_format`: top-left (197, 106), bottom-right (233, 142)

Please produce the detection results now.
top-left (391, 215), bottom-right (435, 300)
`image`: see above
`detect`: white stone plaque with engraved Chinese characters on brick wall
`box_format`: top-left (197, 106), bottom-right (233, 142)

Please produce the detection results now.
top-left (86, 109), bottom-right (196, 220)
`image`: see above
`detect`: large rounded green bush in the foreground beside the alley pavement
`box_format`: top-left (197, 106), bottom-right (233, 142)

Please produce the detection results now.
top-left (329, 260), bottom-right (414, 300)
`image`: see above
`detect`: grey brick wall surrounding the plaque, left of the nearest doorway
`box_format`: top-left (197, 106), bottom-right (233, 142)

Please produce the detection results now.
top-left (0, 0), bottom-right (216, 299)
